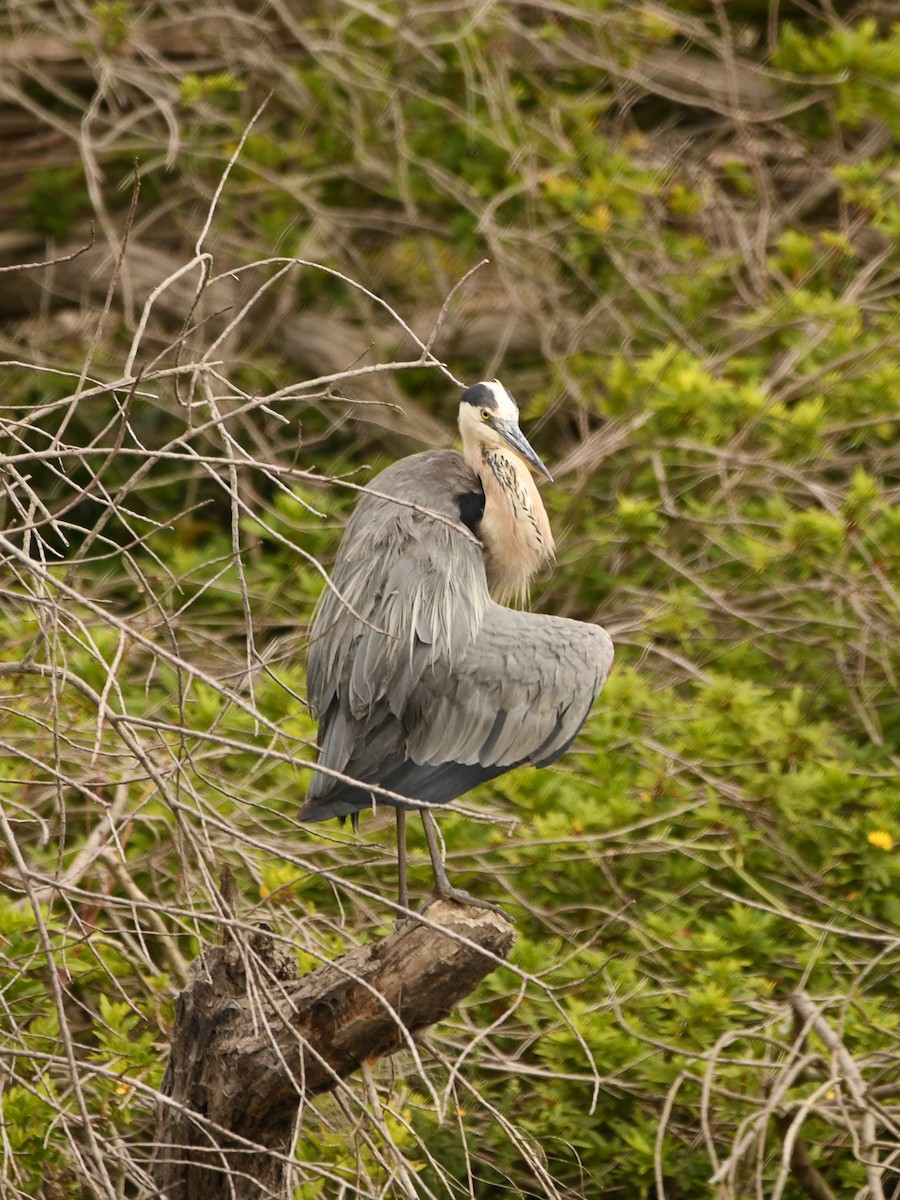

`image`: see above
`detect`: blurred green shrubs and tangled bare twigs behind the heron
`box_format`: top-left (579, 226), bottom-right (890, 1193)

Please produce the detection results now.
top-left (0, 0), bottom-right (900, 1200)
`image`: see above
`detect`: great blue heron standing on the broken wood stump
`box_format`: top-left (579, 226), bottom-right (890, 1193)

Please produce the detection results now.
top-left (300, 380), bottom-right (613, 908)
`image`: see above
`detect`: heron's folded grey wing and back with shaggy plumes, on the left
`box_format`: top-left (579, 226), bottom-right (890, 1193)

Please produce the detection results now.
top-left (307, 451), bottom-right (490, 806)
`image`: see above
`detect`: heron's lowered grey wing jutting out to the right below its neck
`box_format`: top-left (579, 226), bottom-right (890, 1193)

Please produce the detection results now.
top-left (300, 605), bottom-right (613, 821)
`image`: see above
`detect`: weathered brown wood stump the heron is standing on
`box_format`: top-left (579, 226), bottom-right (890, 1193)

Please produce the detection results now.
top-left (154, 901), bottom-right (515, 1200)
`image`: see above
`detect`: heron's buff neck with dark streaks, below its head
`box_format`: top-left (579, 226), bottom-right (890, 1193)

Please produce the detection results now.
top-left (466, 445), bottom-right (553, 601)
